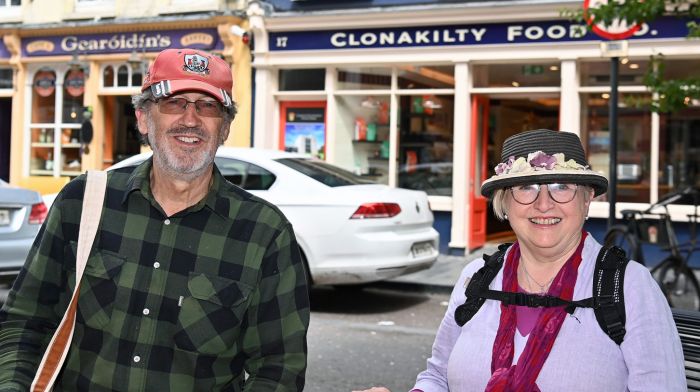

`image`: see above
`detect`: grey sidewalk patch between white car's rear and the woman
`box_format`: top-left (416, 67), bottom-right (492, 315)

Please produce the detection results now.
top-left (387, 243), bottom-right (498, 292)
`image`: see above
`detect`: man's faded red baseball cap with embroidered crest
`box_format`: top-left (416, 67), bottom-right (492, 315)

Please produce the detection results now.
top-left (141, 49), bottom-right (233, 107)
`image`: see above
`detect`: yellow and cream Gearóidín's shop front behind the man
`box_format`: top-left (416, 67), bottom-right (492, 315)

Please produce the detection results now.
top-left (0, 19), bottom-right (250, 192)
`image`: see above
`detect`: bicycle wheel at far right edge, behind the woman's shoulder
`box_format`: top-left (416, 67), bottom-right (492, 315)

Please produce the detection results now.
top-left (656, 257), bottom-right (700, 310)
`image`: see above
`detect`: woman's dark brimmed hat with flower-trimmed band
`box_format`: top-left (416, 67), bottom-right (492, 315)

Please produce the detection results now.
top-left (481, 129), bottom-right (608, 197)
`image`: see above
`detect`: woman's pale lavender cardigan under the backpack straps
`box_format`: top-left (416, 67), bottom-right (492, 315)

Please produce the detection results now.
top-left (414, 235), bottom-right (687, 392)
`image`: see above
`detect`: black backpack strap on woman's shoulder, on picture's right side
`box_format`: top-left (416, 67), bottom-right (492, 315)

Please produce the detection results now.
top-left (593, 246), bottom-right (629, 345)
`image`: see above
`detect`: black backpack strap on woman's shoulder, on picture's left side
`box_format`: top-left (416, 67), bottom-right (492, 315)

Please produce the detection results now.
top-left (455, 243), bottom-right (511, 327)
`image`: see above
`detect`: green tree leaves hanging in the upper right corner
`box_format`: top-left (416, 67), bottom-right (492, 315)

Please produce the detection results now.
top-left (561, 0), bottom-right (700, 113)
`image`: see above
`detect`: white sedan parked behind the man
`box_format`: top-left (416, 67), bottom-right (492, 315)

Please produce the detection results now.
top-left (110, 147), bottom-right (439, 285)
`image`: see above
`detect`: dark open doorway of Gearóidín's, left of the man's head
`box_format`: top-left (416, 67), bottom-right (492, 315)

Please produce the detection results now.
top-left (103, 96), bottom-right (141, 168)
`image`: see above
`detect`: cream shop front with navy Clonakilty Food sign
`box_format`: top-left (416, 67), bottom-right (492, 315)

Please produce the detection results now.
top-left (249, 2), bottom-right (700, 252)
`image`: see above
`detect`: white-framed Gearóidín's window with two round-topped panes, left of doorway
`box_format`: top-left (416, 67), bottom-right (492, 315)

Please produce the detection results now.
top-left (29, 68), bottom-right (85, 176)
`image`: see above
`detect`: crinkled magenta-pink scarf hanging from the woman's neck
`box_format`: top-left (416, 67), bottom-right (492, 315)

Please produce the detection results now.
top-left (486, 232), bottom-right (587, 392)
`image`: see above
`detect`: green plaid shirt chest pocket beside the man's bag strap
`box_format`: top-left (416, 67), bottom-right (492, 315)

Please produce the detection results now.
top-left (66, 243), bottom-right (124, 329)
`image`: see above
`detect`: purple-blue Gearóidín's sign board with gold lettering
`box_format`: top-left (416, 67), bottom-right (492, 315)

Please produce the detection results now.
top-left (22, 29), bottom-right (224, 57)
